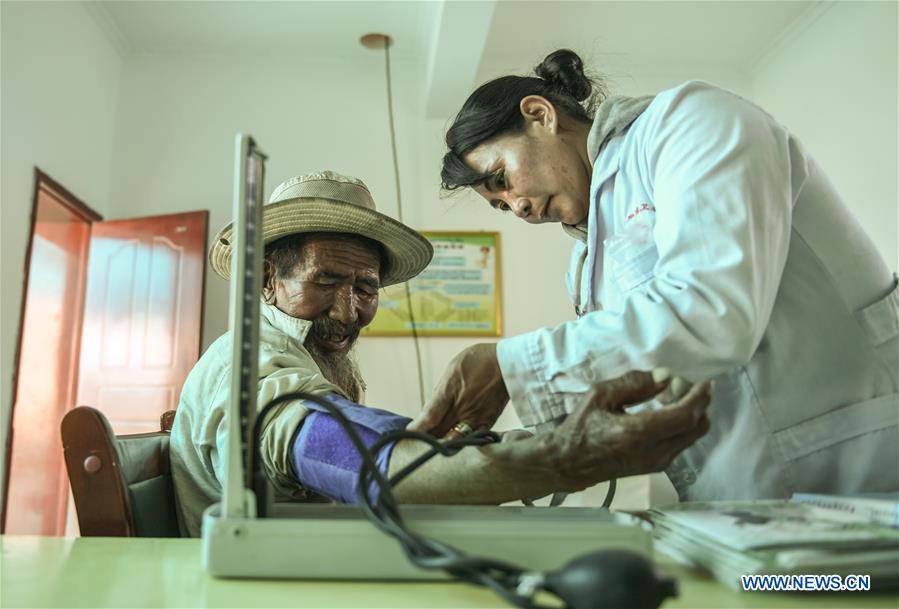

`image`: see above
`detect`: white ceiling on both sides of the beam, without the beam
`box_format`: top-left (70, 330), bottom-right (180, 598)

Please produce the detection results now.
top-left (96, 0), bottom-right (814, 67)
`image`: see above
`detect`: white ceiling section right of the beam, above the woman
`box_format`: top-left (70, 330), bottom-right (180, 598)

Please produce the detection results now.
top-left (484, 0), bottom-right (815, 69)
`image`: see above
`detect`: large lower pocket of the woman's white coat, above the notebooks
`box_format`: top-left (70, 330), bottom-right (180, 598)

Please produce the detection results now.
top-left (774, 393), bottom-right (899, 493)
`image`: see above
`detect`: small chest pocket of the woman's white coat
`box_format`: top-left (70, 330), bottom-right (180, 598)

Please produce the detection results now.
top-left (603, 219), bottom-right (659, 292)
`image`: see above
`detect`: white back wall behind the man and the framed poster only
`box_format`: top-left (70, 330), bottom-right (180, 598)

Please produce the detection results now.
top-left (100, 51), bottom-right (570, 414)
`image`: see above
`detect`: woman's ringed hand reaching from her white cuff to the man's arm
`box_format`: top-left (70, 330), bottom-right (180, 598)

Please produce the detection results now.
top-left (408, 343), bottom-right (509, 438)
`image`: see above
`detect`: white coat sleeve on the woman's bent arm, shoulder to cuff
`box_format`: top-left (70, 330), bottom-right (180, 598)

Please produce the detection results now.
top-left (497, 83), bottom-right (806, 425)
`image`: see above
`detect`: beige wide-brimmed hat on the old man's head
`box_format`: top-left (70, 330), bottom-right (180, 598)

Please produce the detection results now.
top-left (209, 171), bottom-right (434, 286)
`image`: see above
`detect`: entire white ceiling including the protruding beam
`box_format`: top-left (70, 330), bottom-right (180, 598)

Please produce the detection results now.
top-left (91, 0), bottom-right (832, 117)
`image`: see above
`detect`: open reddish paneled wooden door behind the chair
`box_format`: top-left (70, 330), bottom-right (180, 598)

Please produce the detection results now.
top-left (78, 211), bottom-right (208, 434)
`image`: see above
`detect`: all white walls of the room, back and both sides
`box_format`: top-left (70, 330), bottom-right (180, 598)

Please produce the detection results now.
top-left (0, 2), bottom-right (897, 512)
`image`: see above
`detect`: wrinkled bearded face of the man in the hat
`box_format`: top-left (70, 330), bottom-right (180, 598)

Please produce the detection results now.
top-left (263, 233), bottom-right (381, 401)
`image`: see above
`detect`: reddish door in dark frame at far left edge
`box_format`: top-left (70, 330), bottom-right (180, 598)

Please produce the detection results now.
top-left (3, 171), bottom-right (100, 535)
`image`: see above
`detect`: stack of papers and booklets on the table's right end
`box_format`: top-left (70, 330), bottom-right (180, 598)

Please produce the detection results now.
top-left (649, 500), bottom-right (899, 588)
